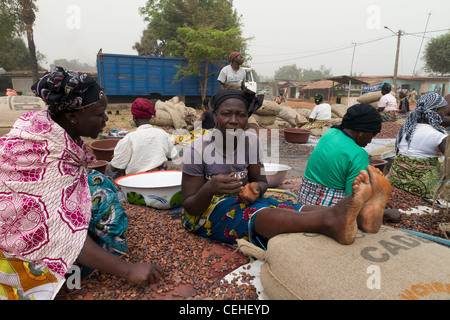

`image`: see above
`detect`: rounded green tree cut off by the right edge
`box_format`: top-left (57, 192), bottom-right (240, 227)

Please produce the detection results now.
top-left (422, 32), bottom-right (450, 75)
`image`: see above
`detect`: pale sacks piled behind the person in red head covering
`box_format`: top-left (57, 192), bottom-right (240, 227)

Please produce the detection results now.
top-left (150, 97), bottom-right (197, 129)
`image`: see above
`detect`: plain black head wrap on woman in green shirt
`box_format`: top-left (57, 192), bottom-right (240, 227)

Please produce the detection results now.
top-left (332, 103), bottom-right (382, 133)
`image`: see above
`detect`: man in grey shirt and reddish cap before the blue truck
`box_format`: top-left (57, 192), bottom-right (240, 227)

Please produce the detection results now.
top-left (217, 52), bottom-right (246, 90)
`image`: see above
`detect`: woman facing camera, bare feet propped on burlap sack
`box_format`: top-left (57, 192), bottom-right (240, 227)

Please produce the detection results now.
top-left (181, 90), bottom-right (389, 247)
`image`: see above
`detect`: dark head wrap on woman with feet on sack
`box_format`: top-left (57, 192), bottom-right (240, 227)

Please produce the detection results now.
top-left (209, 89), bottom-right (264, 117)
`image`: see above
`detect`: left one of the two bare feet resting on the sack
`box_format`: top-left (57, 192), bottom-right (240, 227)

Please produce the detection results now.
top-left (332, 170), bottom-right (372, 244)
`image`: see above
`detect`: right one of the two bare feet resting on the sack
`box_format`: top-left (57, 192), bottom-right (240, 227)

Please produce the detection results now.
top-left (357, 165), bottom-right (392, 233)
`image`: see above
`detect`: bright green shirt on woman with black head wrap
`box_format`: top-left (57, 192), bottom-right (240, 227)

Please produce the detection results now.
top-left (304, 128), bottom-right (369, 195)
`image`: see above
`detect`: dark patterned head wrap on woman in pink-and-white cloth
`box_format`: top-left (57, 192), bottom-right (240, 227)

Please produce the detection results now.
top-left (31, 67), bottom-right (105, 114)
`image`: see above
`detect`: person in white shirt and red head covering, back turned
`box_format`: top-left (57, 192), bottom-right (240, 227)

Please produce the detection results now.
top-left (110, 98), bottom-right (177, 178)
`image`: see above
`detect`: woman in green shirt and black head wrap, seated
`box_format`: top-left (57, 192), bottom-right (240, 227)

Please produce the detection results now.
top-left (298, 104), bottom-right (398, 224)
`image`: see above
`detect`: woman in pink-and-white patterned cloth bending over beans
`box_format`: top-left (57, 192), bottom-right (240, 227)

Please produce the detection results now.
top-left (0, 67), bottom-right (161, 299)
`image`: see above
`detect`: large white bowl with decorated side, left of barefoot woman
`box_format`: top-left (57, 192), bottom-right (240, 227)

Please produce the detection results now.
top-left (116, 170), bottom-right (182, 210)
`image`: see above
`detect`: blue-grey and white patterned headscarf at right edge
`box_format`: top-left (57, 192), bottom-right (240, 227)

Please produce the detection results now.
top-left (395, 92), bottom-right (447, 148)
